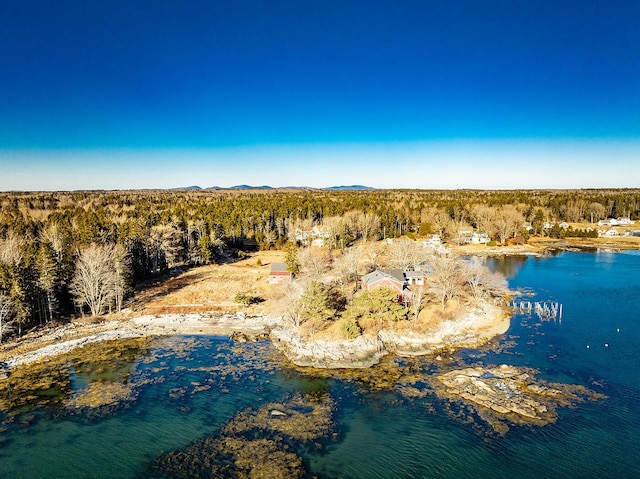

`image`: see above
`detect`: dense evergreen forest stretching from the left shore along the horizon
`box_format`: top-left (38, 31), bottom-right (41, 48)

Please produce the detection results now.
top-left (0, 189), bottom-right (640, 341)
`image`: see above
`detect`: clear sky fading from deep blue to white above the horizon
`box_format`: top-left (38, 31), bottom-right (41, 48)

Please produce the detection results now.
top-left (0, 0), bottom-right (640, 191)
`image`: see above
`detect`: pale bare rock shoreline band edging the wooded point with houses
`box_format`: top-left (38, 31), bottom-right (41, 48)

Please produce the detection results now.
top-left (0, 303), bottom-right (510, 371)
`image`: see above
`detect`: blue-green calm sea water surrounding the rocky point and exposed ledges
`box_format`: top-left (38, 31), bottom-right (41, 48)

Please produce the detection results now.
top-left (0, 252), bottom-right (640, 479)
